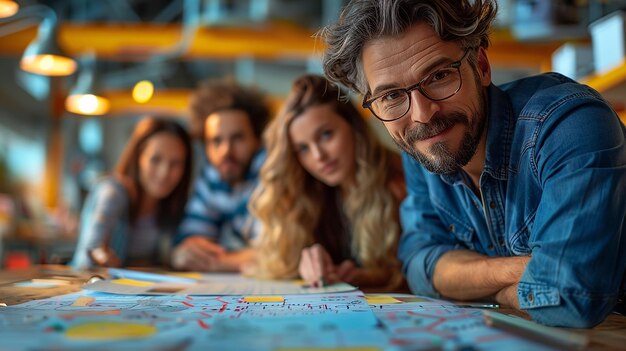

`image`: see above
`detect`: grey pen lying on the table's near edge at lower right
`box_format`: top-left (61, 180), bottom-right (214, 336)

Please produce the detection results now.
top-left (483, 311), bottom-right (589, 350)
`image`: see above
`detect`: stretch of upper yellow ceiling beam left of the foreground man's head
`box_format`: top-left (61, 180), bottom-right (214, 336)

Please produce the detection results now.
top-left (0, 23), bottom-right (323, 61)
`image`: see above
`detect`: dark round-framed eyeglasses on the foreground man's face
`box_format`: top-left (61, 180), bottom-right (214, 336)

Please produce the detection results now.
top-left (363, 49), bottom-right (470, 122)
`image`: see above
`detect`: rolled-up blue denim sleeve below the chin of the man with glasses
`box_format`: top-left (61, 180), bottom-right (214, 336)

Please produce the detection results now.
top-left (398, 153), bottom-right (458, 297)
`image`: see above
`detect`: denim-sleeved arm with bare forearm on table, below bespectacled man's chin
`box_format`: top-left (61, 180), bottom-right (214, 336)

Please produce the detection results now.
top-left (398, 154), bottom-right (529, 306)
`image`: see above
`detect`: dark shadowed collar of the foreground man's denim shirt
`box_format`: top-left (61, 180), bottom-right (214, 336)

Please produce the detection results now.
top-left (441, 84), bottom-right (517, 185)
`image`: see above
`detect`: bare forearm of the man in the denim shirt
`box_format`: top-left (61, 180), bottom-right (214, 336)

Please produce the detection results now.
top-left (433, 250), bottom-right (530, 305)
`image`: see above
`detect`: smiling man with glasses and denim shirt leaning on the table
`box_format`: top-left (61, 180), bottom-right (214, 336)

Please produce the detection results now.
top-left (321, 0), bottom-right (626, 327)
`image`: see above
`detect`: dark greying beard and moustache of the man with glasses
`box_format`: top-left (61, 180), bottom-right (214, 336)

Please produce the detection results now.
top-left (392, 94), bottom-right (487, 174)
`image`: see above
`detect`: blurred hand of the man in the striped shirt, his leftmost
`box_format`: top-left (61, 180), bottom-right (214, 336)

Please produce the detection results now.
top-left (172, 235), bottom-right (226, 272)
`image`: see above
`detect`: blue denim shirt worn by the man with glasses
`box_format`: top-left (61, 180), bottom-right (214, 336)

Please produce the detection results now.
top-left (399, 73), bottom-right (626, 327)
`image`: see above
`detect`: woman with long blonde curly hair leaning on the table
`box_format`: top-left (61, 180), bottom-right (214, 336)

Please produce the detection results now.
top-left (250, 75), bottom-right (405, 288)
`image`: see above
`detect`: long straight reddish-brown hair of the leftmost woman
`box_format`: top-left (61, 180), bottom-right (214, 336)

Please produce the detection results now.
top-left (115, 117), bottom-right (192, 230)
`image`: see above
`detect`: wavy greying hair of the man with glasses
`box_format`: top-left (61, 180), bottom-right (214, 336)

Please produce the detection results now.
top-left (318, 0), bottom-right (498, 94)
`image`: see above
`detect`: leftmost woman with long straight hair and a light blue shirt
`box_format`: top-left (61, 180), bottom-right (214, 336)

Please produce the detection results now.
top-left (71, 117), bottom-right (192, 269)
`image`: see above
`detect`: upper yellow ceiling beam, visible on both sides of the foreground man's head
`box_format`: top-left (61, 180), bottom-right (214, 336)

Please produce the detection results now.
top-left (0, 22), bottom-right (562, 71)
